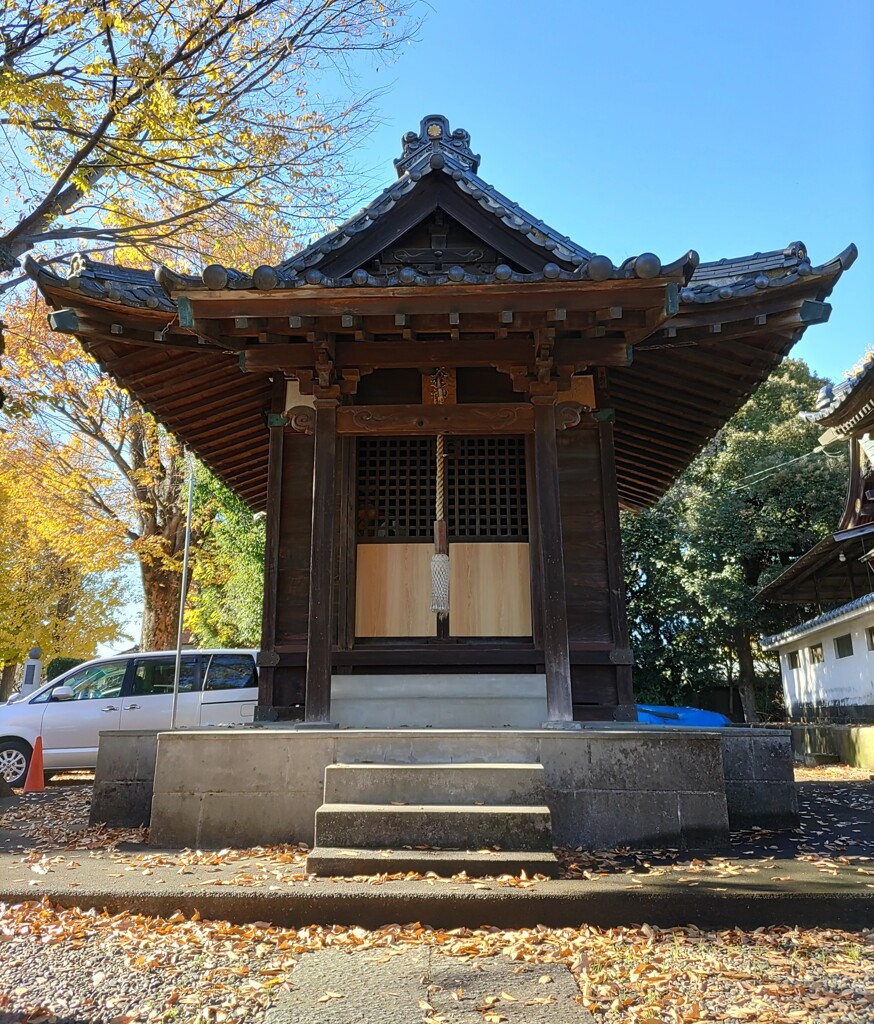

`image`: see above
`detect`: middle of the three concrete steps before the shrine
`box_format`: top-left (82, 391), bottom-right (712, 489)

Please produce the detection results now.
top-left (314, 803), bottom-right (553, 851)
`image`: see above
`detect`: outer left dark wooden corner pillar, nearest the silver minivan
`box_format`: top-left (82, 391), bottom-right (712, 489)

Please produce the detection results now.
top-left (258, 374), bottom-right (288, 720)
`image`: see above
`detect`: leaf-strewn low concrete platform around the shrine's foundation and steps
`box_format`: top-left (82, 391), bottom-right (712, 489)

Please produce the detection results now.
top-left (0, 781), bottom-right (874, 931)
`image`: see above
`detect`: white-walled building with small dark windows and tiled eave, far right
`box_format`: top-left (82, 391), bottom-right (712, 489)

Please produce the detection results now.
top-left (761, 594), bottom-right (874, 720)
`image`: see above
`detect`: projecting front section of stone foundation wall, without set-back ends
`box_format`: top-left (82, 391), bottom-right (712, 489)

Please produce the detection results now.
top-left (151, 727), bottom-right (728, 849)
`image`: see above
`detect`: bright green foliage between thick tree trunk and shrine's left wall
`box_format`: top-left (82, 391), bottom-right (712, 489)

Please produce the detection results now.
top-left (185, 466), bottom-right (264, 647)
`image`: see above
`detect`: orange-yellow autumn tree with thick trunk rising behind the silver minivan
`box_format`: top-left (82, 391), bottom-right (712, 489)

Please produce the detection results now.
top-left (4, 290), bottom-right (196, 648)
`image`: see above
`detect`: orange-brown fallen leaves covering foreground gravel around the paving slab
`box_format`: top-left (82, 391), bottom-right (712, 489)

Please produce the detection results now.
top-left (0, 901), bottom-right (874, 1024)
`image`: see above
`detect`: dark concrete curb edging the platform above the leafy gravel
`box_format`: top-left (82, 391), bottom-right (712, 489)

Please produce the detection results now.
top-left (0, 871), bottom-right (874, 931)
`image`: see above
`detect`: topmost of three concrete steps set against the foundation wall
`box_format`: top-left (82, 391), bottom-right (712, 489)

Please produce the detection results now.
top-left (324, 764), bottom-right (547, 806)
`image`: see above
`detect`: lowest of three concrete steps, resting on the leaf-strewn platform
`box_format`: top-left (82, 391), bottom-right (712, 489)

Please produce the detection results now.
top-left (307, 846), bottom-right (561, 879)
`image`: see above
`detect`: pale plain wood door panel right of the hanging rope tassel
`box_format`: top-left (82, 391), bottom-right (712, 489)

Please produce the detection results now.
top-left (449, 541), bottom-right (531, 637)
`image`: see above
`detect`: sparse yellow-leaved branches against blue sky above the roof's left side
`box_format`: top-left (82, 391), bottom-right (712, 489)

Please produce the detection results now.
top-left (0, 0), bottom-right (414, 293)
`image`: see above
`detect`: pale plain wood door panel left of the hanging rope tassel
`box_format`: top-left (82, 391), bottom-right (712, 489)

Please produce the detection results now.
top-left (355, 544), bottom-right (436, 637)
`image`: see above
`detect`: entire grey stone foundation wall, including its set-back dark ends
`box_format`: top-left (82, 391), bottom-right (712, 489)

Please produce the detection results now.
top-left (91, 724), bottom-right (802, 849)
